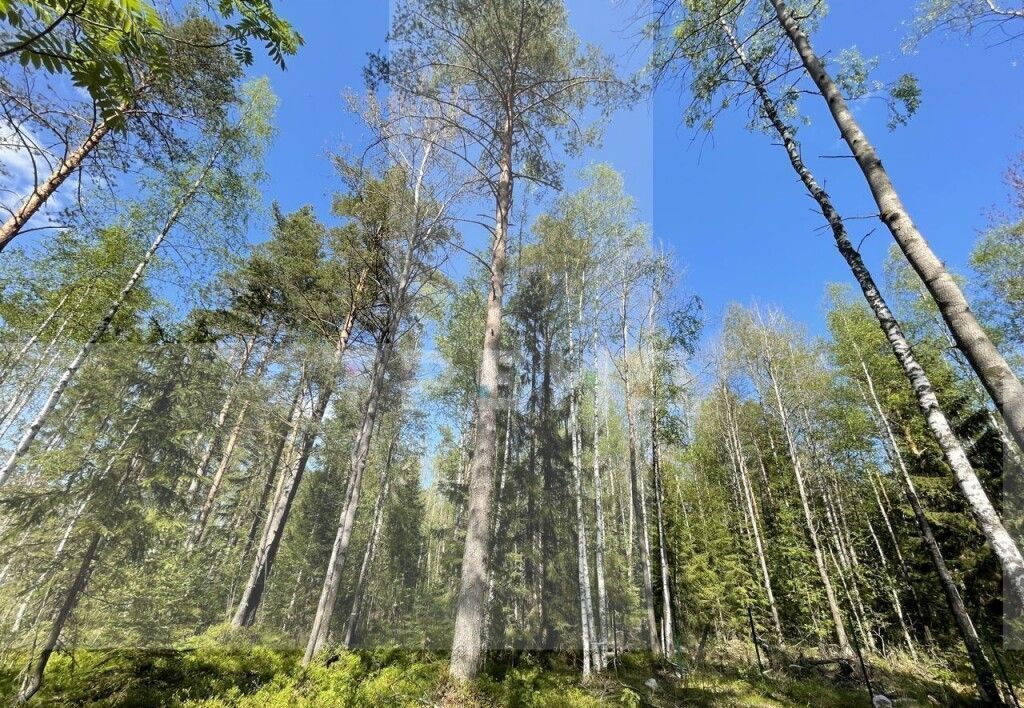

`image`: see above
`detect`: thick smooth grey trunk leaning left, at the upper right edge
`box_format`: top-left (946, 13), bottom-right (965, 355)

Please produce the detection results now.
top-left (771, 0), bottom-right (1024, 454)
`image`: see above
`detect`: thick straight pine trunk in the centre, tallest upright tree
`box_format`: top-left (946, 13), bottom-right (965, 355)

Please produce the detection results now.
top-left (450, 126), bottom-right (513, 681)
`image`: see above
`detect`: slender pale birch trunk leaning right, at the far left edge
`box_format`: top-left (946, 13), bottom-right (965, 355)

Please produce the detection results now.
top-left (0, 153), bottom-right (216, 487)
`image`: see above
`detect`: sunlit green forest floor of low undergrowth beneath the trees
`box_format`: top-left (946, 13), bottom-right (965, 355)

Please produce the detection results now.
top-left (0, 638), bottom-right (1007, 708)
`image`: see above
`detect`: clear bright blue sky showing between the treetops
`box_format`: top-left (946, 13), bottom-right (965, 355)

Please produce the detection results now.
top-left (247, 0), bottom-right (1024, 342)
